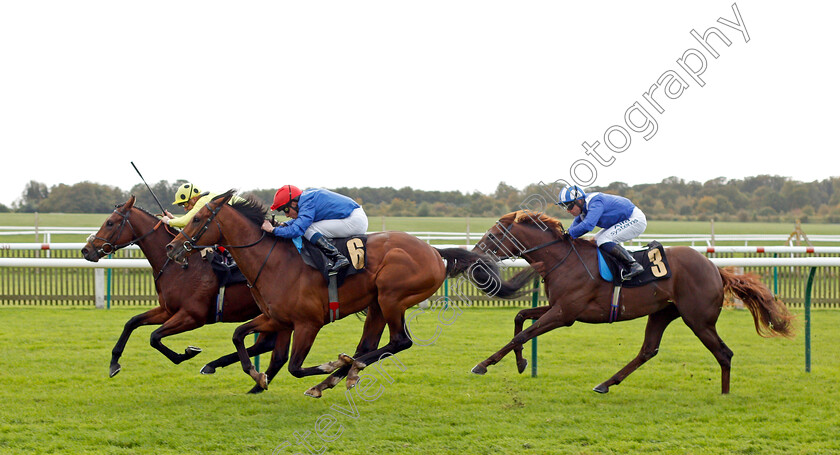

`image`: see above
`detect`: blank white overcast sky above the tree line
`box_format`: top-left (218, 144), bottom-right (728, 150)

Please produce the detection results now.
top-left (0, 0), bottom-right (840, 205)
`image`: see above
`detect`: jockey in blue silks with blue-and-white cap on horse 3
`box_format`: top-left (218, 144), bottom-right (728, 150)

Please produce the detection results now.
top-left (557, 185), bottom-right (647, 280)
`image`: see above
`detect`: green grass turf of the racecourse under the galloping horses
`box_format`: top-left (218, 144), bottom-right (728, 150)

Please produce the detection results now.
top-left (0, 307), bottom-right (840, 454)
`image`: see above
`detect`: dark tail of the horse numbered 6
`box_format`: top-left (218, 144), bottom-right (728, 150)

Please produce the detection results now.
top-left (436, 248), bottom-right (537, 299)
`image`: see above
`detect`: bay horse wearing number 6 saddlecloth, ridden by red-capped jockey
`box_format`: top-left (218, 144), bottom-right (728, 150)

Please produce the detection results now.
top-left (166, 190), bottom-right (506, 398)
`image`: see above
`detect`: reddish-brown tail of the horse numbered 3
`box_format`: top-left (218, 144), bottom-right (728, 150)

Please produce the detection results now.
top-left (718, 267), bottom-right (794, 338)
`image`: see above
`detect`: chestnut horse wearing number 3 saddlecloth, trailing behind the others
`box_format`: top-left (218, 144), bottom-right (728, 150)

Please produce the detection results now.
top-left (472, 211), bottom-right (793, 394)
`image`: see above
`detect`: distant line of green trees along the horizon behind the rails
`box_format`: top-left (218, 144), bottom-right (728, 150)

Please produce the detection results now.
top-left (6, 175), bottom-right (840, 223)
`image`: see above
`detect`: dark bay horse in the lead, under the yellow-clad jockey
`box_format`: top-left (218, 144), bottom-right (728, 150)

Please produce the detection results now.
top-left (81, 196), bottom-right (275, 384)
